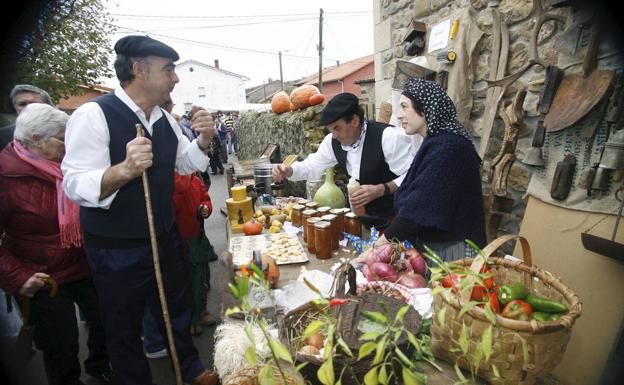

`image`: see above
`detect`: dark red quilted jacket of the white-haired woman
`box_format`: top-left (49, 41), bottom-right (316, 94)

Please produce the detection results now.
top-left (0, 144), bottom-right (89, 294)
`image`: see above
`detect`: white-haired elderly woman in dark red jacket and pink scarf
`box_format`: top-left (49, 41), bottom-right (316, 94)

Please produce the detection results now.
top-left (0, 104), bottom-right (111, 385)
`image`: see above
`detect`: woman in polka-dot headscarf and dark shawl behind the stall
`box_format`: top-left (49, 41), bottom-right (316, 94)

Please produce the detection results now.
top-left (379, 78), bottom-right (486, 261)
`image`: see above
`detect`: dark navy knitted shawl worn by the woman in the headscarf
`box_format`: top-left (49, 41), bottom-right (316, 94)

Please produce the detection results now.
top-left (385, 132), bottom-right (486, 247)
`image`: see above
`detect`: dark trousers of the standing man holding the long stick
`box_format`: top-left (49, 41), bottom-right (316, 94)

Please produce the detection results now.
top-left (85, 230), bottom-right (204, 385)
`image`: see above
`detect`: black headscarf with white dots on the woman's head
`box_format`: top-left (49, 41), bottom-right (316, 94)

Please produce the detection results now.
top-left (403, 78), bottom-right (472, 140)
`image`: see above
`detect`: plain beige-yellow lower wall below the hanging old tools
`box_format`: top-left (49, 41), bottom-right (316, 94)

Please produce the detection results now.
top-left (514, 197), bottom-right (624, 385)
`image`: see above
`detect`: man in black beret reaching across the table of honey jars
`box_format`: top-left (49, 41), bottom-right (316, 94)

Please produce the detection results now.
top-left (273, 92), bottom-right (415, 229)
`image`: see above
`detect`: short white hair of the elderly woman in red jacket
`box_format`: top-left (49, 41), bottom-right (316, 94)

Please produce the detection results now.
top-left (13, 103), bottom-right (69, 145)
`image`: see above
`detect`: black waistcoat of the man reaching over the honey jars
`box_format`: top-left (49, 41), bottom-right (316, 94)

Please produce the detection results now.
top-left (332, 120), bottom-right (398, 218)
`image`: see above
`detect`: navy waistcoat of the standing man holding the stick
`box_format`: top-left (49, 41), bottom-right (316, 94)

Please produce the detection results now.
top-left (80, 93), bottom-right (178, 239)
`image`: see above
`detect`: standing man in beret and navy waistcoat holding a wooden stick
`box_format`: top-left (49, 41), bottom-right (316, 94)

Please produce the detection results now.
top-left (61, 36), bottom-right (218, 385)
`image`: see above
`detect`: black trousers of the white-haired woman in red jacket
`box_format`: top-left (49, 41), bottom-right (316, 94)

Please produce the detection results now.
top-left (31, 279), bottom-right (110, 385)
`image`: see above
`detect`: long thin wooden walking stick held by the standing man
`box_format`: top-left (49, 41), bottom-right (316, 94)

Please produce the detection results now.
top-left (135, 123), bottom-right (182, 385)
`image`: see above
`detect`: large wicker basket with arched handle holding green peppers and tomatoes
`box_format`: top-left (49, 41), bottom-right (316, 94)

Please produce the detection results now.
top-left (431, 235), bottom-right (581, 385)
